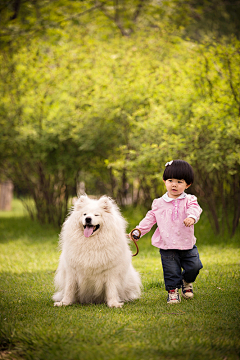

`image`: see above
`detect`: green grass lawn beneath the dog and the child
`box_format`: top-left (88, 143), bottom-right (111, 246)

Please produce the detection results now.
top-left (0, 200), bottom-right (240, 360)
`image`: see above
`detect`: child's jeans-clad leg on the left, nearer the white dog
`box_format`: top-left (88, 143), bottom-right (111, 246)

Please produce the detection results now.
top-left (160, 249), bottom-right (182, 291)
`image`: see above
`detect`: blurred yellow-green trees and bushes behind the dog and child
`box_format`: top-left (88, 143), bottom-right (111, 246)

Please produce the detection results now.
top-left (0, 0), bottom-right (240, 235)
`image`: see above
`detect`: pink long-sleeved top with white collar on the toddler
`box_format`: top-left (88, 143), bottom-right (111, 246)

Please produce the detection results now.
top-left (137, 192), bottom-right (202, 250)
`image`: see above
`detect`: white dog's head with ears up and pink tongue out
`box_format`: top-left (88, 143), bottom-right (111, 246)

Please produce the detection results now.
top-left (74, 196), bottom-right (112, 238)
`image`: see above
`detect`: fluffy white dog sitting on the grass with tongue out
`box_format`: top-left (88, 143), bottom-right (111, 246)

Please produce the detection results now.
top-left (53, 196), bottom-right (141, 307)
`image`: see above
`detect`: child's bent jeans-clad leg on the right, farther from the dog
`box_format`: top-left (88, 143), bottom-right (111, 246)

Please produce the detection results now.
top-left (180, 245), bottom-right (203, 283)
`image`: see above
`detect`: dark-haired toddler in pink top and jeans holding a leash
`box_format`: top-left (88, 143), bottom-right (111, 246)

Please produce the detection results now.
top-left (133, 160), bottom-right (203, 304)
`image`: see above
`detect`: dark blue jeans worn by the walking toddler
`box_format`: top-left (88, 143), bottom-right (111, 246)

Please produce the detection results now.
top-left (159, 245), bottom-right (203, 291)
